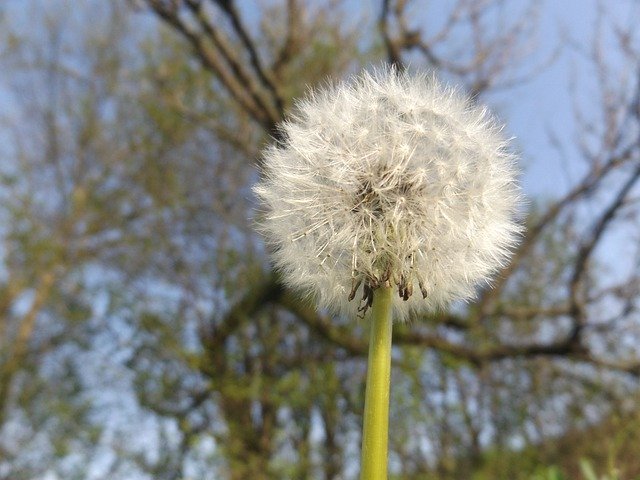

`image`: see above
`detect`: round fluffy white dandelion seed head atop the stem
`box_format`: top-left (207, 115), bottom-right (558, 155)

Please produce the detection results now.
top-left (254, 69), bottom-right (521, 318)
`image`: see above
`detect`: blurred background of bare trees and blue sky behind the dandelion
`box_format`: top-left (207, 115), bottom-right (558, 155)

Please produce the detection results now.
top-left (0, 0), bottom-right (640, 480)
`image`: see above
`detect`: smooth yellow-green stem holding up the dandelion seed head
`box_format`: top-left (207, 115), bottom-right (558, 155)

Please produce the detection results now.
top-left (360, 288), bottom-right (392, 480)
